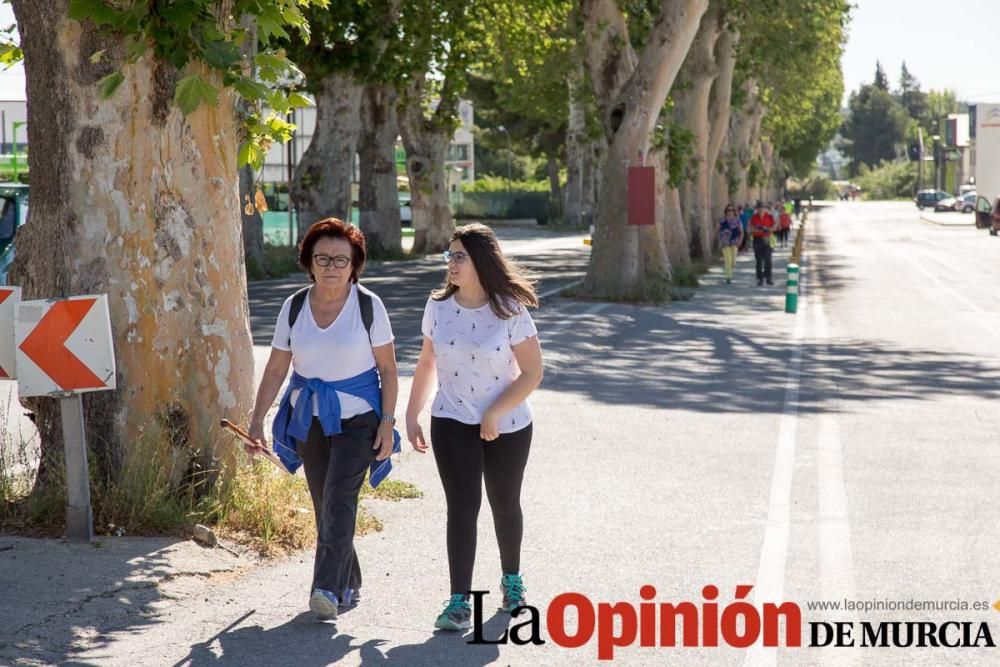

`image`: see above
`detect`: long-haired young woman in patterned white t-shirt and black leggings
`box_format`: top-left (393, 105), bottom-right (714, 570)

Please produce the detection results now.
top-left (406, 224), bottom-right (542, 630)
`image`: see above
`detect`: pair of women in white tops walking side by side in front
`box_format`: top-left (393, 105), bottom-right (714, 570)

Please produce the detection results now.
top-left (249, 218), bottom-right (542, 630)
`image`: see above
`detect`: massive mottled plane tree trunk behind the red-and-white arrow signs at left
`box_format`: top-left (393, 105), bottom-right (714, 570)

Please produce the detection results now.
top-left (11, 0), bottom-right (324, 500)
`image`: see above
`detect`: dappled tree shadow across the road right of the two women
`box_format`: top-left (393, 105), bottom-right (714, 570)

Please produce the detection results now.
top-left (539, 306), bottom-right (1000, 413)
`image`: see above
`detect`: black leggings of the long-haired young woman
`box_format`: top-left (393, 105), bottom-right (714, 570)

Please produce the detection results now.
top-left (431, 417), bottom-right (531, 593)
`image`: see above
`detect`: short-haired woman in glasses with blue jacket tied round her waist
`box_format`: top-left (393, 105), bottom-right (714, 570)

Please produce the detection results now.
top-left (249, 218), bottom-right (399, 619)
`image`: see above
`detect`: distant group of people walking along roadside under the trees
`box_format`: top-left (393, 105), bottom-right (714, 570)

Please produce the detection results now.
top-left (718, 199), bottom-right (802, 286)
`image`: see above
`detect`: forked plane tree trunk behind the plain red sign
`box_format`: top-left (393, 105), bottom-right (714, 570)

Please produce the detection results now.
top-left (582, 0), bottom-right (708, 299)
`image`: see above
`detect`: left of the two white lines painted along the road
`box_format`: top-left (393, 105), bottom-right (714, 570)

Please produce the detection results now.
top-left (743, 264), bottom-right (809, 666)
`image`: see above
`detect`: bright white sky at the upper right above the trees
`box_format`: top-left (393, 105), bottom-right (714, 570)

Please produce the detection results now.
top-left (841, 0), bottom-right (1000, 102)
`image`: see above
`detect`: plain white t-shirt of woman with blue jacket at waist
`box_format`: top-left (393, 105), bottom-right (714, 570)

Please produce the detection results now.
top-left (271, 284), bottom-right (393, 419)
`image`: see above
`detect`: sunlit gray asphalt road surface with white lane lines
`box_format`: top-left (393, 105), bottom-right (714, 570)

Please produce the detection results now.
top-left (0, 203), bottom-right (1000, 665)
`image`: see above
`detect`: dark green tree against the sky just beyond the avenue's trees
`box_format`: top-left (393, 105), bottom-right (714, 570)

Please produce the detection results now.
top-left (841, 84), bottom-right (909, 174)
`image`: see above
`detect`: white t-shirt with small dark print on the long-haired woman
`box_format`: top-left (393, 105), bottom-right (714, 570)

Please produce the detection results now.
top-left (420, 296), bottom-right (538, 433)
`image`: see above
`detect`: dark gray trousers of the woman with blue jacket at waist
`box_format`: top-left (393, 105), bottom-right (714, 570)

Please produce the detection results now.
top-left (298, 410), bottom-right (379, 598)
